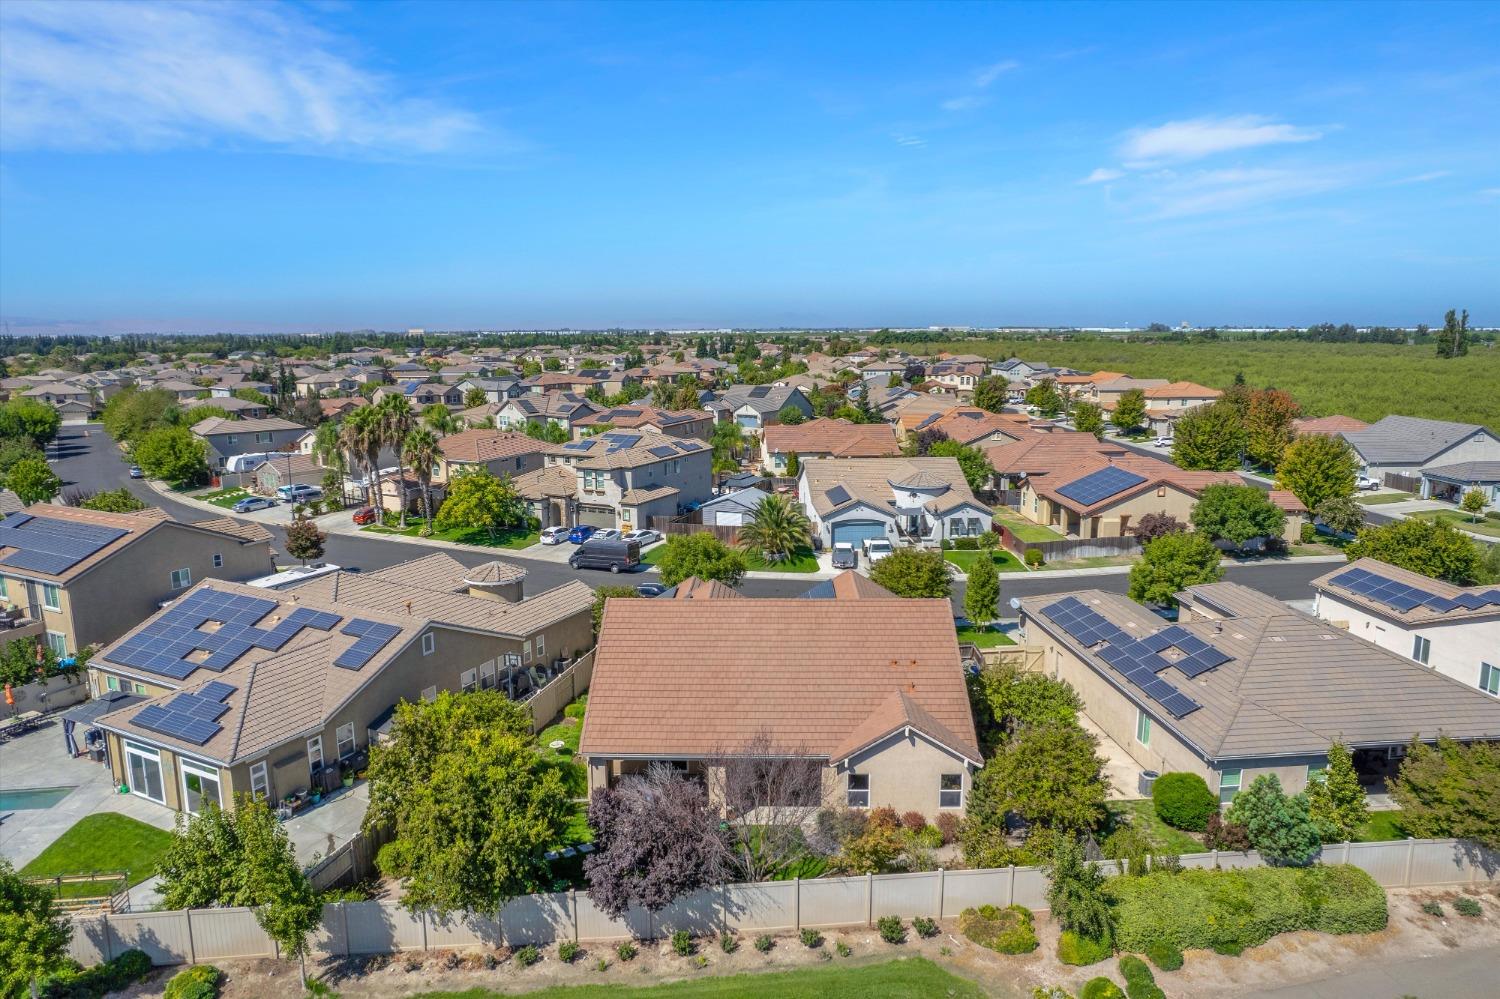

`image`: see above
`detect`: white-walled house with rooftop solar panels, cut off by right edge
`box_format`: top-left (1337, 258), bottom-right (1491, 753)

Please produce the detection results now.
top-left (1313, 558), bottom-right (1500, 696)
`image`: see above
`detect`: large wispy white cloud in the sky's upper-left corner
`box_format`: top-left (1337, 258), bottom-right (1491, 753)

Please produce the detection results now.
top-left (0, 0), bottom-right (480, 155)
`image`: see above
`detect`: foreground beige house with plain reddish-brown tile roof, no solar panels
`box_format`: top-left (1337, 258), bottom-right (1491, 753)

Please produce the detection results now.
top-left (579, 584), bottom-right (983, 818)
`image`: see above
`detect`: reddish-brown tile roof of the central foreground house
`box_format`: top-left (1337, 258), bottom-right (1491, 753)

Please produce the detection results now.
top-left (581, 599), bottom-right (980, 759)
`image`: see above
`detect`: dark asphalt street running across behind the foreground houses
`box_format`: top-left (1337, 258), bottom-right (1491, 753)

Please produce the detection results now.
top-left (51, 425), bottom-right (1329, 608)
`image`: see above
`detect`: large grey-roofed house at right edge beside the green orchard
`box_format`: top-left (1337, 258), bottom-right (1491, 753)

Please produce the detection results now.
top-left (1344, 416), bottom-right (1500, 500)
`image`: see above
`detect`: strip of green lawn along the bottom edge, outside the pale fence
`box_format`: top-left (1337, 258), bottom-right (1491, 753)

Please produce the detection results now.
top-left (417, 948), bottom-right (986, 999)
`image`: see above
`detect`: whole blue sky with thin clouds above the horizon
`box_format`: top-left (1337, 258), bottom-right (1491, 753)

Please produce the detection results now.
top-left (0, 0), bottom-right (1500, 330)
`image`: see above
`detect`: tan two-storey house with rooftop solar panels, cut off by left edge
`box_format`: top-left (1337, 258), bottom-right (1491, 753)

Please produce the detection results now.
top-left (0, 503), bottom-right (275, 656)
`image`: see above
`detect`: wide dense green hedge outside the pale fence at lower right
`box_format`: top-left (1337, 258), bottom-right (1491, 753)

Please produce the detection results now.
top-left (1104, 866), bottom-right (1386, 954)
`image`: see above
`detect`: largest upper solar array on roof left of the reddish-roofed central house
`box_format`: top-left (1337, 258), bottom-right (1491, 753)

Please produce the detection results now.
top-left (110, 588), bottom-right (342, 680)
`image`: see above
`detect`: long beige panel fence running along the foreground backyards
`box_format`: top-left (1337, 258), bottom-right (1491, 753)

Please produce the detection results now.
top-left (71, 840), bottom-right (1500, 965)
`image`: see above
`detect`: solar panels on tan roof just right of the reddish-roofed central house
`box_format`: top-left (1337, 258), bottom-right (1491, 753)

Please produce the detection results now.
top-left (1047, 597), bottom-right (1233, 719)
